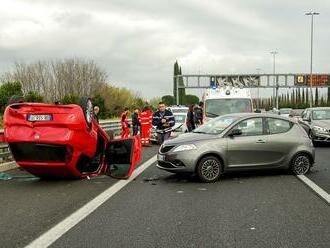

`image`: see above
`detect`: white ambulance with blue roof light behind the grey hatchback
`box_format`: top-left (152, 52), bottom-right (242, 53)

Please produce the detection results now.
top-left (203, 86), bottom-right (254, 121)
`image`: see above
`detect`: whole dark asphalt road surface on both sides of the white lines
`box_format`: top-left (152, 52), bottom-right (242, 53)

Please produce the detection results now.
top-left (0, 146), bottom-right (330, 247)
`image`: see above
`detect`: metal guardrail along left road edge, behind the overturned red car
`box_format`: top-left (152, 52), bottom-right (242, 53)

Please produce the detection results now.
top-left (0, 120), bottom-right (128, 163)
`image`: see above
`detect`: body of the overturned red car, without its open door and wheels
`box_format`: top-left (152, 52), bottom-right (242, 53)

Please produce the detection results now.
top-left (4, 103), bottom-right (109, 178)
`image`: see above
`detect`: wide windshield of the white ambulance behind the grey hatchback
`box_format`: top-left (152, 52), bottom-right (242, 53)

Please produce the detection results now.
top-left (205, 99), bottom-right (252, 118)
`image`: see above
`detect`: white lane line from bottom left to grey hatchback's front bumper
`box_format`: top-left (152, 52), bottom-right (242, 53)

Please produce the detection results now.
top-left (26, 155), bottom-right (157, 248)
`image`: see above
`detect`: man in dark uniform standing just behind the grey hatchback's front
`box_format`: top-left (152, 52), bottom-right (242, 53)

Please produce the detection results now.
top-left (152, 102), bottom-right (175, 144)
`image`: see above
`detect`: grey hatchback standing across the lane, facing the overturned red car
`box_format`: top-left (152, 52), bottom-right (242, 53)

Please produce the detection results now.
top-left (157, 113), bottom-right (315, 182)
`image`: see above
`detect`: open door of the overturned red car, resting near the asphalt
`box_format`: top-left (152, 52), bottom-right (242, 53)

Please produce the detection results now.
top-left (107, 136), bottom-right (141, 179)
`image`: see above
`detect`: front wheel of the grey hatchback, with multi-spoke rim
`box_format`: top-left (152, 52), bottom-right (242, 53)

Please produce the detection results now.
top-left (196, 156), bottom-right (222, 183)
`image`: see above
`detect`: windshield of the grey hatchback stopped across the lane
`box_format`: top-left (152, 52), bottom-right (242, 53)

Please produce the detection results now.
top-left (193, 116), bottom-right (239, 134)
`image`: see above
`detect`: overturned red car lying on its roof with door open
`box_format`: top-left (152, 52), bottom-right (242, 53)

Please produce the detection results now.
top-left (4, 98), bottom-right (141, 178)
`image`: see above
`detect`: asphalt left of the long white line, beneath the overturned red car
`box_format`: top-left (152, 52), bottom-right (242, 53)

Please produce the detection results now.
top-left (0, 147), bottom-right (158, 247)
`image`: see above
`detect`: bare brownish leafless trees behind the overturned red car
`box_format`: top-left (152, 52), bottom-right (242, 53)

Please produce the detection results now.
top-left (1, 58), bottom-right (107, 102)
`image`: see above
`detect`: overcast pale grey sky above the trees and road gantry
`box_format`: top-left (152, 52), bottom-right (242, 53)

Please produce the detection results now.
top-left (0, 0), bottom-right (330, 99)
